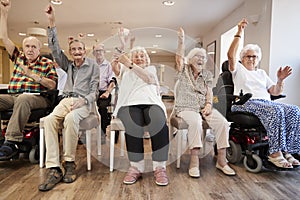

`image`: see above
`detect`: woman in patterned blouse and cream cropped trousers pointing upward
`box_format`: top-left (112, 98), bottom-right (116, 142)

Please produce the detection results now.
top-left (175, 28), bottom-right (235, 178)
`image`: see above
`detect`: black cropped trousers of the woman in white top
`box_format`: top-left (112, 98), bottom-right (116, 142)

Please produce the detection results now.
top-left (118, 105), bottom-right (169, 162)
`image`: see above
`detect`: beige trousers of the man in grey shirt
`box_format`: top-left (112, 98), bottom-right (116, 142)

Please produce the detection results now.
top-left (44, 97), bottom-right (89, 168)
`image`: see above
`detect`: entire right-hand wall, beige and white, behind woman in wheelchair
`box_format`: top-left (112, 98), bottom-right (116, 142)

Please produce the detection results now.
top-left (203, 0), bottom-right (300, 105)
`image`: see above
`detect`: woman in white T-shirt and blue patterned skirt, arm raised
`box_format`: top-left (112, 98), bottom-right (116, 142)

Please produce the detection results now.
top-left (228, 19), bottom-right (300, 168)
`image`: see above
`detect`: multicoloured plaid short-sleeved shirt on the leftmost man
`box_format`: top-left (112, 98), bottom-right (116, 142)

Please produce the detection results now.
top-left (8, 48), bottom-right (57, 93)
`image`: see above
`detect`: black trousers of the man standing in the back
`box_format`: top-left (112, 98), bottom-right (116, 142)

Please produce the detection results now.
top-left (97, 90), bottom-right (111, 134)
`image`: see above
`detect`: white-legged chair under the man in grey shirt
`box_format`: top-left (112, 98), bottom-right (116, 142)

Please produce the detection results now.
top-left (40, 102), bottom-right (101, 170)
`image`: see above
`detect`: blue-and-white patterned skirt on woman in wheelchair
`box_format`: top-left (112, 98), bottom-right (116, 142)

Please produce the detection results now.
top-left (231, 99), bottom-right (300, 154)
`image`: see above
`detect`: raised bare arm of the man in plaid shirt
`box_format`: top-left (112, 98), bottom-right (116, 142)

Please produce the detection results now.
top-left (0, 0), bottom-right (15, 55)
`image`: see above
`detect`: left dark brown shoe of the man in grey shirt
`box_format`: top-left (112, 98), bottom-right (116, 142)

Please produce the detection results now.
top-left (39, 168), bottom-right (63, 191)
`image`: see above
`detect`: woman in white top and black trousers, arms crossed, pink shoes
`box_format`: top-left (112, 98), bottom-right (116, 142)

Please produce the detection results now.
top-left (112, 47), bottom-right (169, 185)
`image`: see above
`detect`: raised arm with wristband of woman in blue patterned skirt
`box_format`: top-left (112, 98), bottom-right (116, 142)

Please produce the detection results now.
top-left (227, 19), bottom-right (248, 71)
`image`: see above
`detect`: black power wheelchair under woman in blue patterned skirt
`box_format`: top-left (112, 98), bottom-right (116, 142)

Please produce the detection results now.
top-left (213, 61), bottom-right (291, 173)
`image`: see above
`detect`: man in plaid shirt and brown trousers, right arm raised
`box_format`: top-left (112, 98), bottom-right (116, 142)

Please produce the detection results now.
top-left (0, 0), bottom-right (57, 161)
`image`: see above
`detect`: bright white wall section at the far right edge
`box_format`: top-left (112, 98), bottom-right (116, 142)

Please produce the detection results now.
top-left (269, 0), bottom-right (300, 106)
